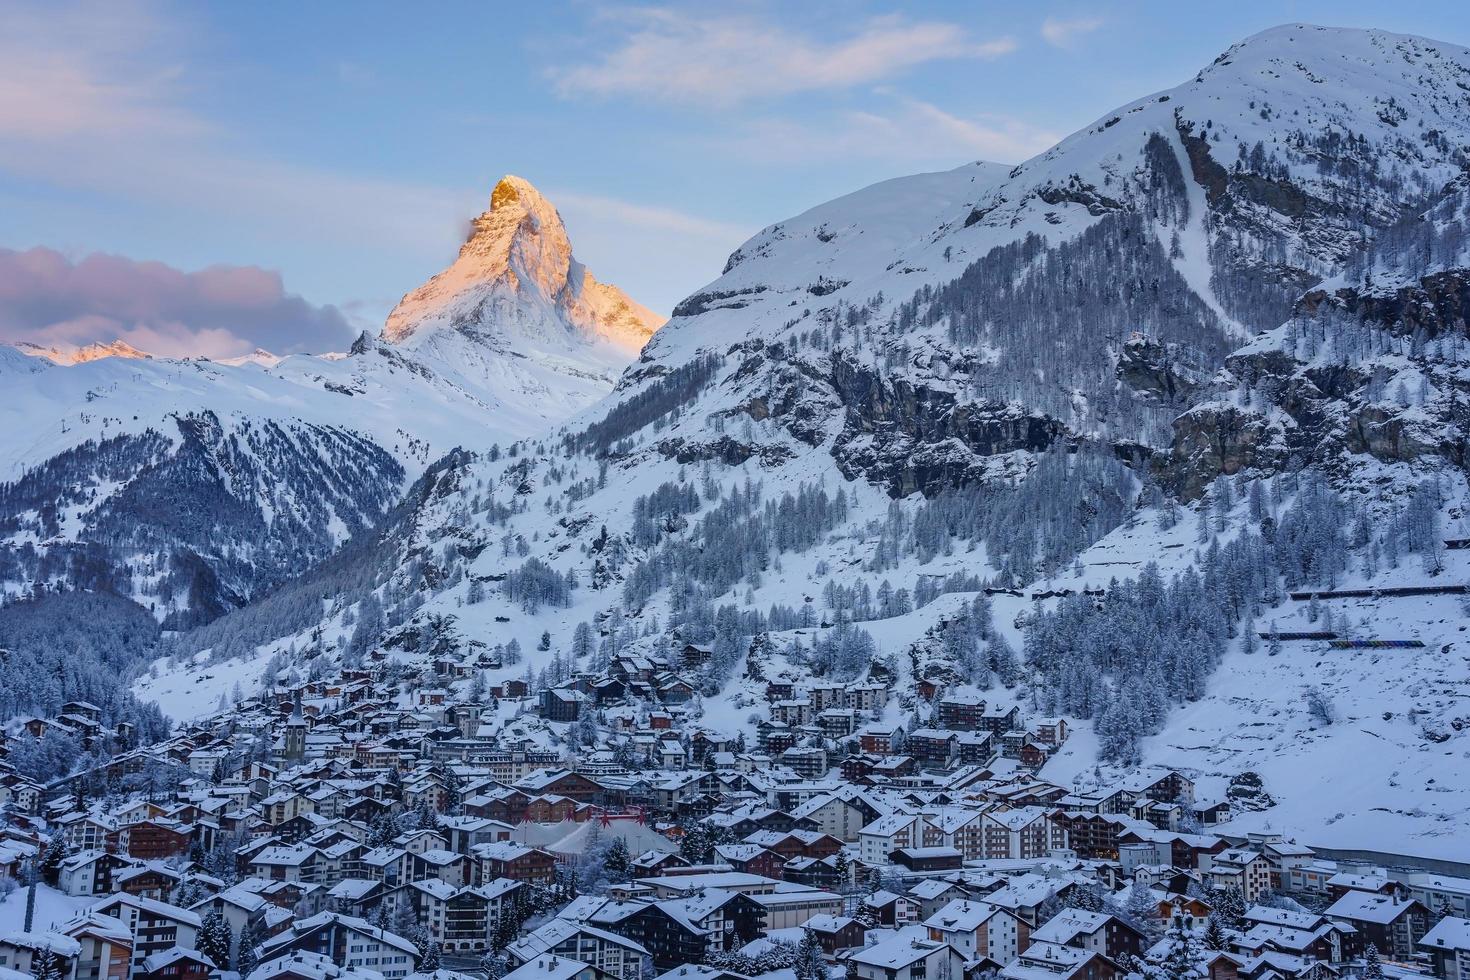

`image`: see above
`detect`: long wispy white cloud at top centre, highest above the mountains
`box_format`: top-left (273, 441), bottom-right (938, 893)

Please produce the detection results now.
top-left (551, 7), bottom-right (1016, 106)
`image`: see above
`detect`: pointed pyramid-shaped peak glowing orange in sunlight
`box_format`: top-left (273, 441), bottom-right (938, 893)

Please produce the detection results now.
top-left (382, 175), bottom-right (663, 359)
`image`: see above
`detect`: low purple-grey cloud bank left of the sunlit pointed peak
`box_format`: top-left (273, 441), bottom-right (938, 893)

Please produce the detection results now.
top-left (0, 247), bottom-right (354, 357)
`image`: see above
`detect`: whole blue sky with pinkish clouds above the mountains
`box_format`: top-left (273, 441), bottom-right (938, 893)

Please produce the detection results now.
top-left (0, 0), bottom-right (1470, 356)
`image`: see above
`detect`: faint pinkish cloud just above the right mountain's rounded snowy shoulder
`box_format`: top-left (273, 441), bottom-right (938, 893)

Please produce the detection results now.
top-left (726, 96), bottom-right (1058, 169)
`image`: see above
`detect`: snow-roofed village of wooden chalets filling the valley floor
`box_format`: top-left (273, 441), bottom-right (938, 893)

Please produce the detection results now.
top-left (0, 644), bottom-right (1470, 980)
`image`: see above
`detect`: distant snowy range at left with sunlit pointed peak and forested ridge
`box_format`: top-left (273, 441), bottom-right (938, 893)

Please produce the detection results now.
top-left (0, 178), bottom-right (660, 624)
